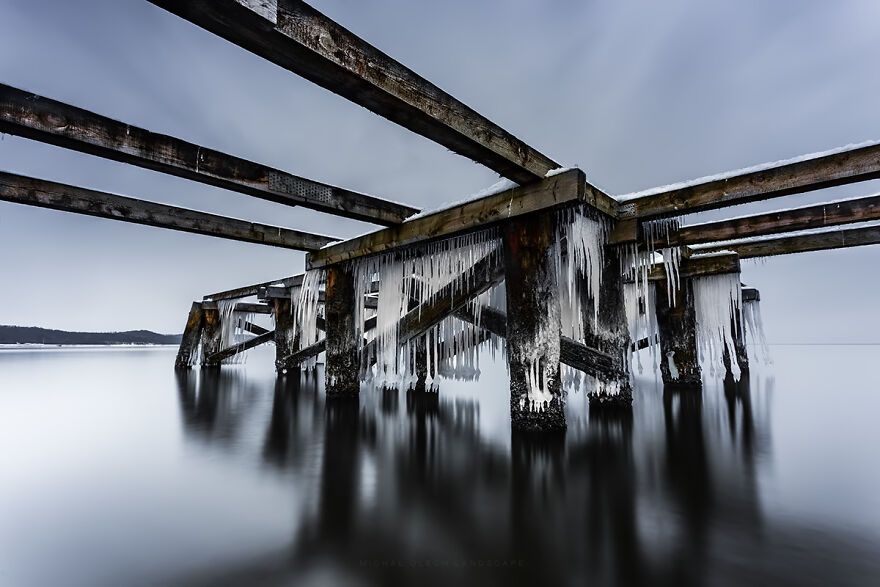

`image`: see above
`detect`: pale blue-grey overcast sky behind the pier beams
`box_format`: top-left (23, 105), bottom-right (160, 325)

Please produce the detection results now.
top-left (0, 0), bottom-right (880, 343)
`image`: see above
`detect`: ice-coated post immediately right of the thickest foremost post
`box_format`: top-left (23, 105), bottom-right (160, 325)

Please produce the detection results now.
top-left (581, 247), bottom-right (632, 406)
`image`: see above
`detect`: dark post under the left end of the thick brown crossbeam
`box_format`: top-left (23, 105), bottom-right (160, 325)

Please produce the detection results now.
top-left (324, 264), bottom-right (360, 398)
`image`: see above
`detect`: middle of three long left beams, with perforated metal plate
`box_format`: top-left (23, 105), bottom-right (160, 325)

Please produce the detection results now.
top-left (0, 84), bottom-right (418, 226)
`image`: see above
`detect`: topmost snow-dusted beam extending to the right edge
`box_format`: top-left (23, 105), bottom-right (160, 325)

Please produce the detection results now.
top-left (617, 144), bottom-right (880, 218)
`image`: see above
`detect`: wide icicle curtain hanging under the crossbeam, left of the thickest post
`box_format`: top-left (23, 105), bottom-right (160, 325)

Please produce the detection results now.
top-left (354, 228), bottom-right (503, 387)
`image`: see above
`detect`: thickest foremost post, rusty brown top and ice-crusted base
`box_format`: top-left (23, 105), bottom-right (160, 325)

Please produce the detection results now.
top-left (503, 211), bottom-right (565, 431)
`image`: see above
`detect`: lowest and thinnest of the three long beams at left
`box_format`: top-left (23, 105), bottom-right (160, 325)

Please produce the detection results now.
top-left (0, 172), bottom-right (334, 251)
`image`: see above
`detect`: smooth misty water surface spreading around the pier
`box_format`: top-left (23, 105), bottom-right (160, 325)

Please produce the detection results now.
top-left (0, 346), bottom-right (880, 587)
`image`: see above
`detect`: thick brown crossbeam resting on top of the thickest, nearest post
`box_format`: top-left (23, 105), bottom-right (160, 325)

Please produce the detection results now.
top-left (306, 169), bottom-right (601, 268)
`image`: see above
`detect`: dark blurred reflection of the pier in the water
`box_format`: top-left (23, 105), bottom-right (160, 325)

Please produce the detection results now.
top-left (168, 370), bottom-right (876, 585)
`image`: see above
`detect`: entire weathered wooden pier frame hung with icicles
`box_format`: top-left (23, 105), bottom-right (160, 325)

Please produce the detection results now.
top-left (0, 0), bottom-right (880, 431)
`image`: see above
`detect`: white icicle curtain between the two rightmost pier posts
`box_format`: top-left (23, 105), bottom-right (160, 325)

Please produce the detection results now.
top-left (693, 273), bottom-right (742, 381)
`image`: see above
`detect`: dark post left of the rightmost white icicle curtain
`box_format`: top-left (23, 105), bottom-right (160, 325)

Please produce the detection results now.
top-left (656, 278), bottom-right (703, 388)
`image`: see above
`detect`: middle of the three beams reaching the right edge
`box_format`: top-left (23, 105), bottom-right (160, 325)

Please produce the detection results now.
top-left (669, 195), bottom-right (880, 245)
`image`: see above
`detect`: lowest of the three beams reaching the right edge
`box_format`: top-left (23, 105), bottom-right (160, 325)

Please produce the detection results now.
top-left (694, 226), bottom-right (880, 259)
